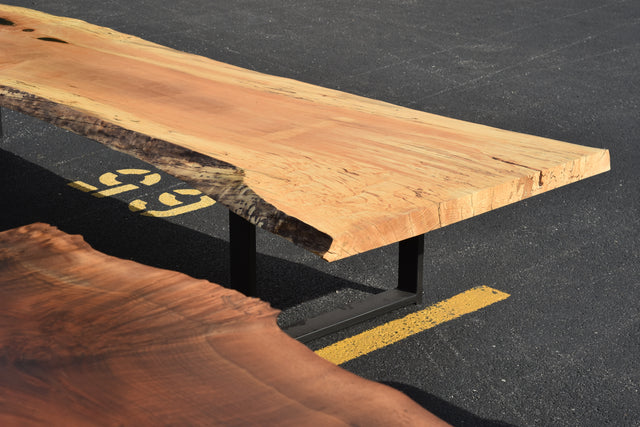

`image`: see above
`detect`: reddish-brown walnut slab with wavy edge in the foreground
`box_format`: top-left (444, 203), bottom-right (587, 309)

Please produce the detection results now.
top-left (0, 224), bottom-right (446, 426)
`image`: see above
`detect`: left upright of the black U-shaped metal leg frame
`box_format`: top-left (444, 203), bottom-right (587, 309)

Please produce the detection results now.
top-left (229, 211), bottom-right (257, 297)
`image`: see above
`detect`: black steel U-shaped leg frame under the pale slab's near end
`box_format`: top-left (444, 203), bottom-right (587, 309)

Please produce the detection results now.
top-left (229, 212), bottom-right (424, 342)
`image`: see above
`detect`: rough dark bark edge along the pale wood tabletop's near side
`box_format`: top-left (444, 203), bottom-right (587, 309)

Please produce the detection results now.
top-left (0, 85), bottom-right (333, 256)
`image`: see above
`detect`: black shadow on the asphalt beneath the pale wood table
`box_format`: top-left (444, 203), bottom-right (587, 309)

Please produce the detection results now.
top-left (0, 150), bottom-right (382, 318)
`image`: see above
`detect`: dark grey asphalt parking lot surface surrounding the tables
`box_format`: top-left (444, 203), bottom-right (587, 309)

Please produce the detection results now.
top-left (0, 0), bottom-right (640, 426)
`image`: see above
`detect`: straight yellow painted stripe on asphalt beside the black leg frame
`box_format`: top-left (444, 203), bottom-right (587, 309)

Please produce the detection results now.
top-left (316, 286), bottom-right (510, 365)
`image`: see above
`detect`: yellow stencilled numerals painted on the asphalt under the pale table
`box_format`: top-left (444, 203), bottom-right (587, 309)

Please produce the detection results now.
top-left (68, 169), bottom-right (216, 218)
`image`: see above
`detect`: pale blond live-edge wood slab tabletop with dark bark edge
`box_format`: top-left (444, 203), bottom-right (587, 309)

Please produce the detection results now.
top-left (0, 6), bottom-right (609, 261)
